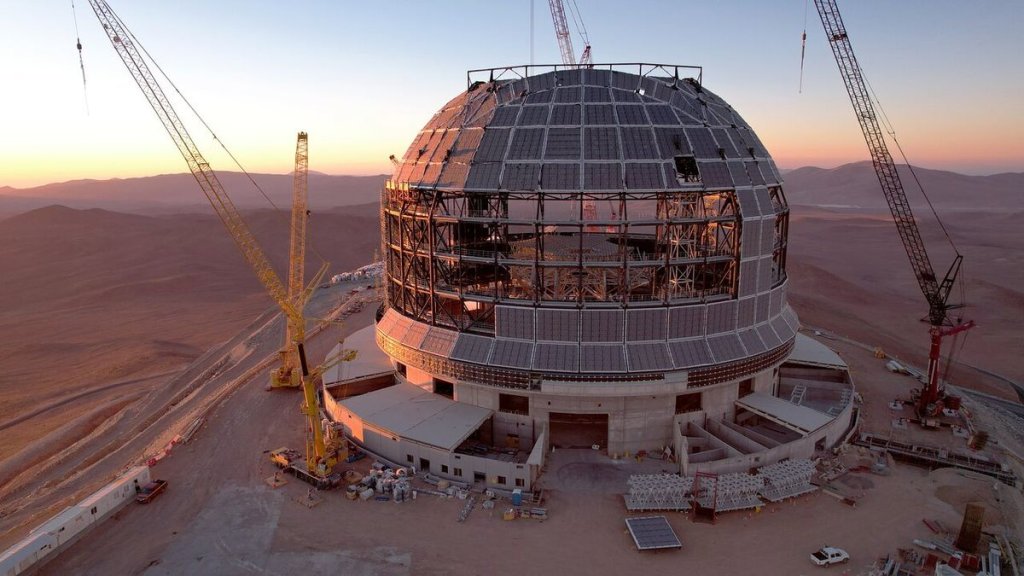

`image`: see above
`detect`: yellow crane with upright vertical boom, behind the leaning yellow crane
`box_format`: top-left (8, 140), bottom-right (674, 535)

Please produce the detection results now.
top-left (270, 132), bottom-right (328, 388)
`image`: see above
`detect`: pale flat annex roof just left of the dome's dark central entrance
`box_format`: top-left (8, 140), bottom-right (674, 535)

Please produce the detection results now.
top-left (339, 382), bottom-right (494, 451)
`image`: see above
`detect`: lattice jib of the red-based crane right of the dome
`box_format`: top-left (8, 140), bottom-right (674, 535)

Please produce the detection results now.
top-left (814, 0), bottom-right (959, 326)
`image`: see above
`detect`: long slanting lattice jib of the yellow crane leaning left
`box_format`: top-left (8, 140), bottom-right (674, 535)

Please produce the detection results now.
top-left (89, 0), bottom-right (298, 318)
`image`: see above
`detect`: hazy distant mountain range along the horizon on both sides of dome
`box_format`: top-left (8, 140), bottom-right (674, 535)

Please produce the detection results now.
top-left (0, 162), bottom-right (1024, 217)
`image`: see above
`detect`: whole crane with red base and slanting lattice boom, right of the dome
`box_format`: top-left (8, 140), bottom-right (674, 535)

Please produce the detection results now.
top-left (814, 0), bottom-right (975, 421)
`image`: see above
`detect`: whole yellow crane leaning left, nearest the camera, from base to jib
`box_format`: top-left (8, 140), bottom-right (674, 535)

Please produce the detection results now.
top-left (89, 0), bottom-right (342, 480)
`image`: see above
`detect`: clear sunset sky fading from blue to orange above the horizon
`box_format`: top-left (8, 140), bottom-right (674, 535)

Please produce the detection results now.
top-left (0, 0), bottom-right (1024, 188)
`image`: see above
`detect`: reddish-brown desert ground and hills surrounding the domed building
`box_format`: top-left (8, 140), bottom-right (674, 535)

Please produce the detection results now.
top-left (0, 164), bottom-right (1024, 574)
